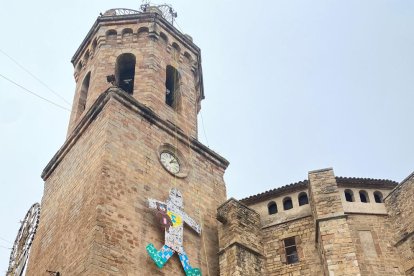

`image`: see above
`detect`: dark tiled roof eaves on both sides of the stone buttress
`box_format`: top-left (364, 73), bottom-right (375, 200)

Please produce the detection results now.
top-left (240, 176), bottom-right (398, 205)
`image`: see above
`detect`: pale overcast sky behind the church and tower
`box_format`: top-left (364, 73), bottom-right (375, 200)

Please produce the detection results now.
top-left (0, 0), bottom-right (414, 274)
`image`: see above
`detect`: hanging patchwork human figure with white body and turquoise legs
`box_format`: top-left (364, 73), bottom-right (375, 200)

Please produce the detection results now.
top-left (147, 188), bottom-right (201, 276)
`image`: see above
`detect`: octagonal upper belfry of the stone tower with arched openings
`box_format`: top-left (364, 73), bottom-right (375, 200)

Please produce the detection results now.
top-left (68, 5), bottom-right (204, 138)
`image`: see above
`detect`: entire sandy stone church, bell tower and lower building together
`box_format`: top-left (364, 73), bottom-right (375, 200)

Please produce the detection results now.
top-left (26, 6), bottom-right (414, 276)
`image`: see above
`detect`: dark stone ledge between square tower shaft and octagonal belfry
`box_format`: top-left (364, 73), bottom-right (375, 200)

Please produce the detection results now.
top-left (41, 87), bottom-right (229, 181)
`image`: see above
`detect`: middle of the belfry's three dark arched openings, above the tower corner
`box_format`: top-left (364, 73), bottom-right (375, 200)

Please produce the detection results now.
top-left (115, 53), bottom-right (136, 94)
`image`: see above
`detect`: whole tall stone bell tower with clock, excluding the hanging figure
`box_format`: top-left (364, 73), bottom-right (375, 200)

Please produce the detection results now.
top-left (27, 7), bottom-right (228, 276)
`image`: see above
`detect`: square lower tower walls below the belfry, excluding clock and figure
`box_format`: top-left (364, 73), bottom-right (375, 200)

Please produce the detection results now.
top-left (28, 89), bottom-right (227, 276)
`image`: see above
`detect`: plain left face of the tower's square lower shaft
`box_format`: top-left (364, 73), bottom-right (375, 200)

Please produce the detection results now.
top-left (26, 92), bottom-right (111, 276)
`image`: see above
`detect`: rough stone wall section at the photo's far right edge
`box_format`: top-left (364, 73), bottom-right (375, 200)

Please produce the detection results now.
top-left (385, 173), bottom-right (414, 275)
